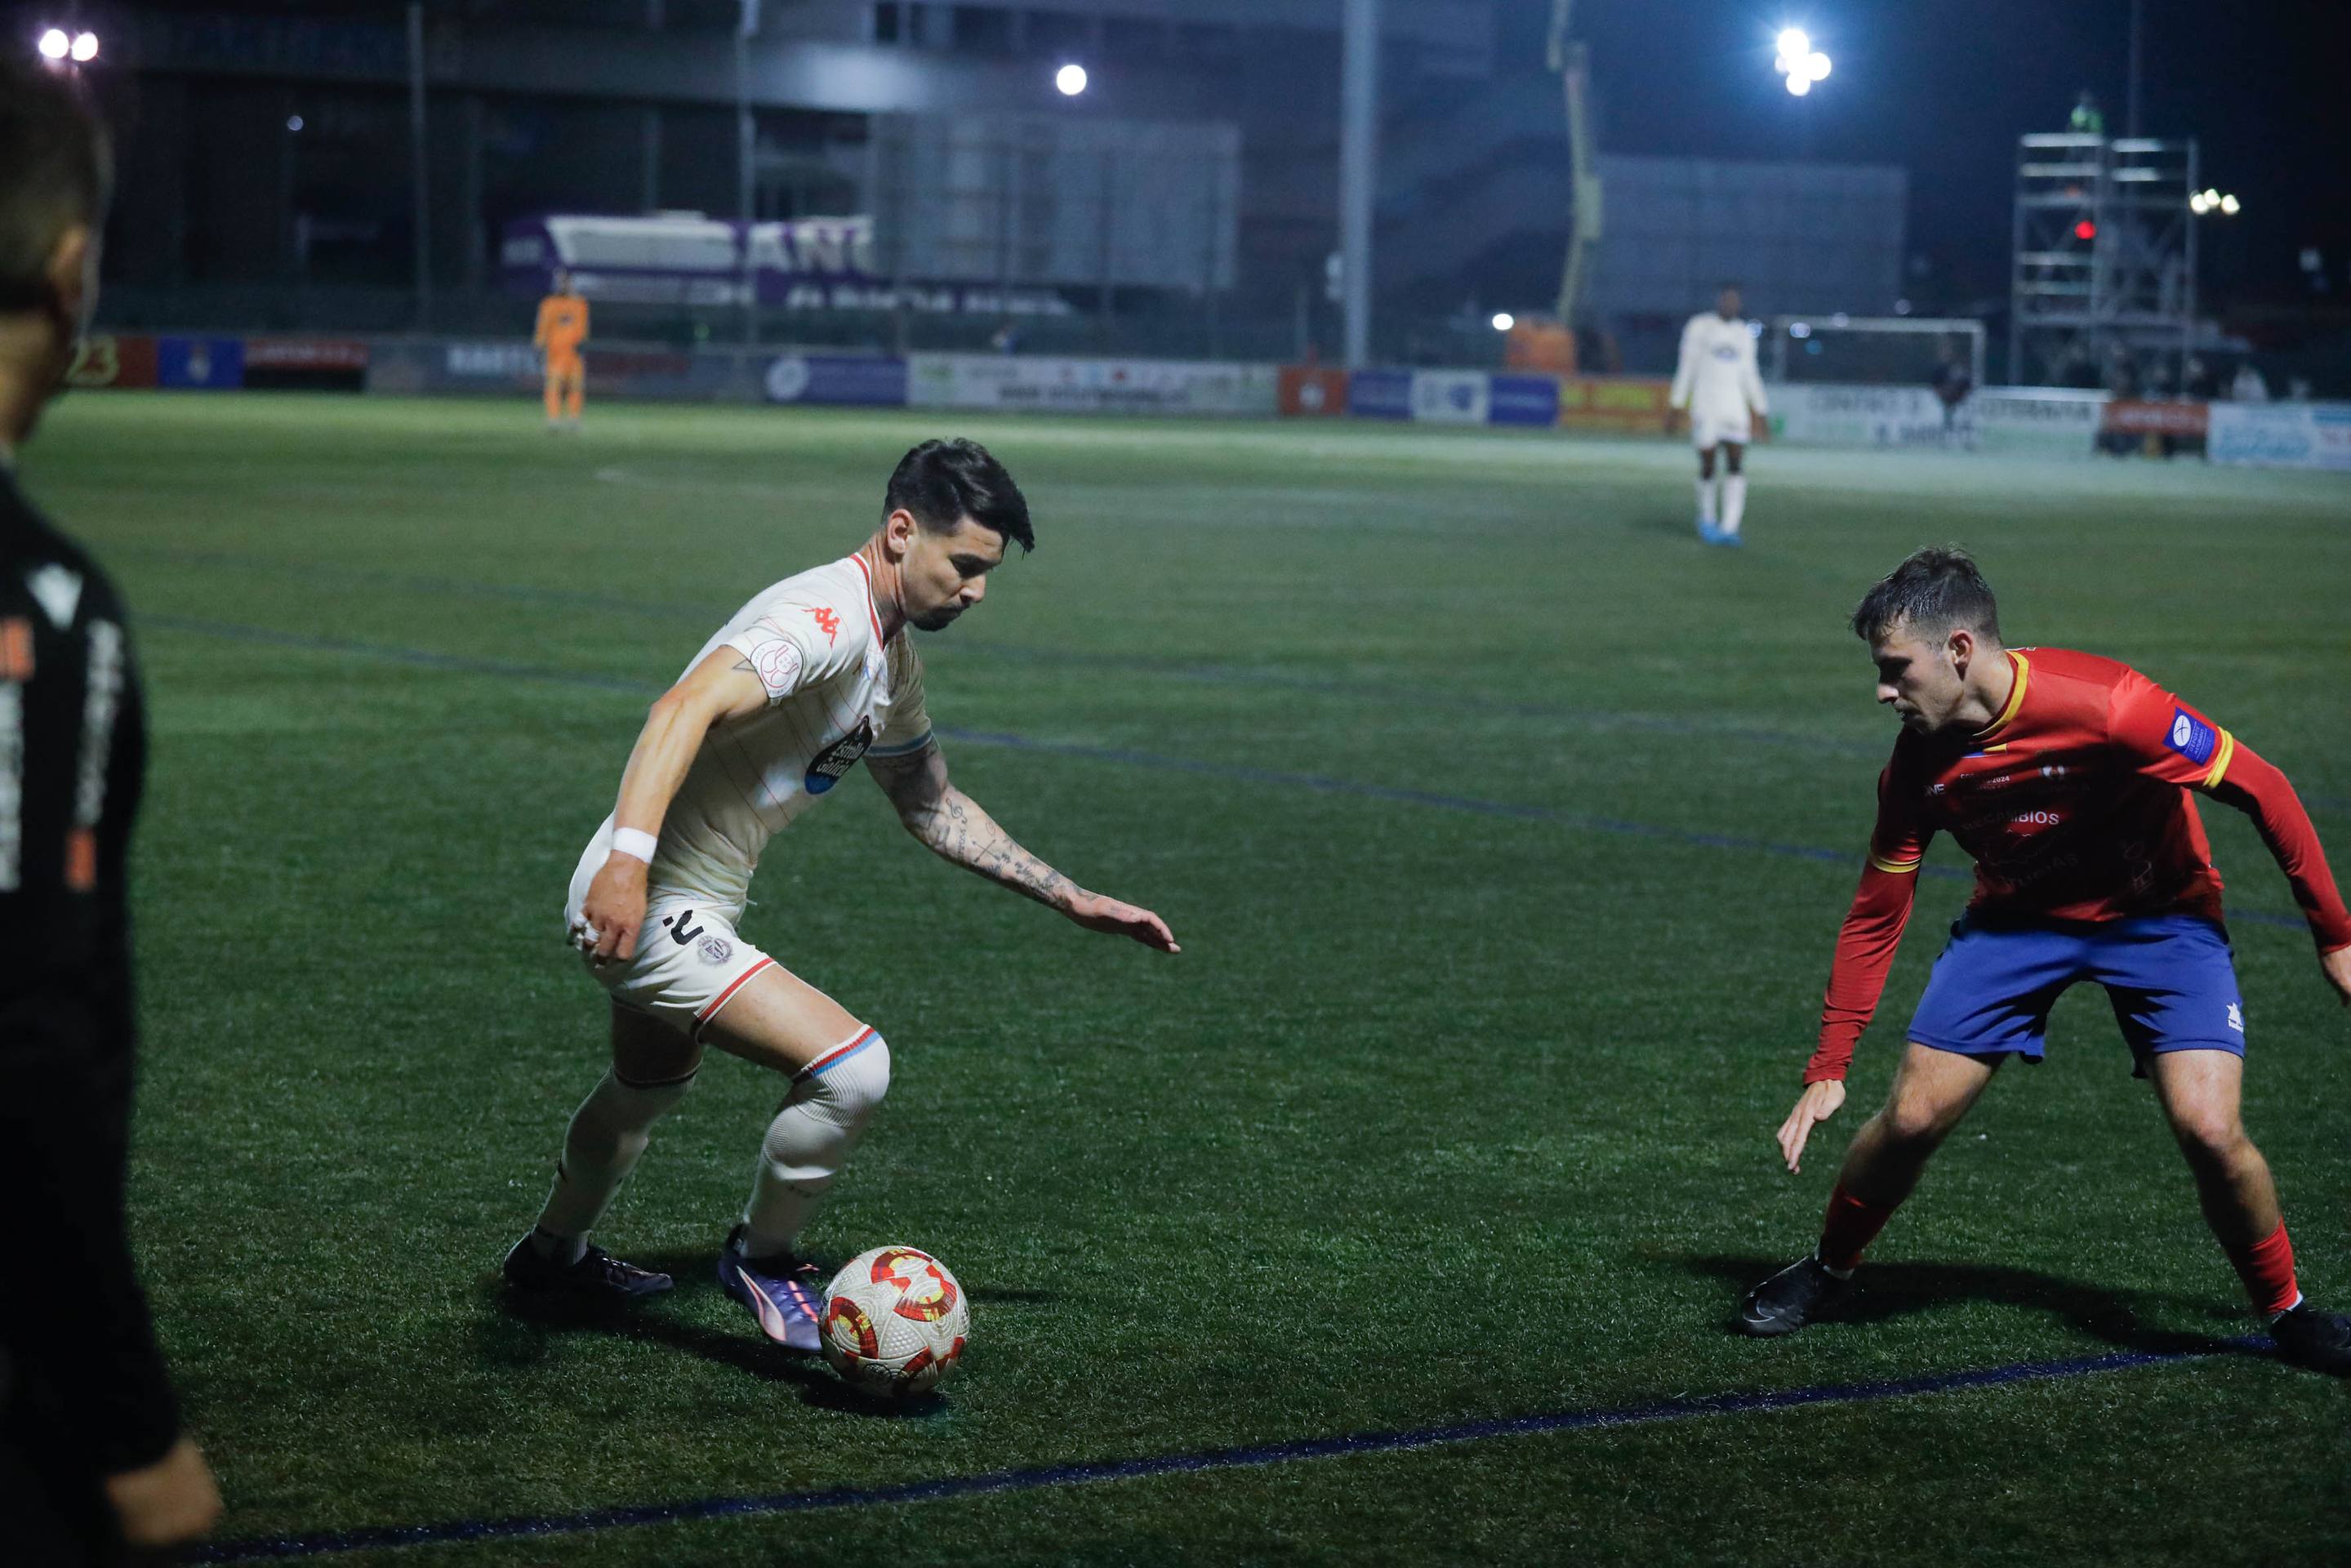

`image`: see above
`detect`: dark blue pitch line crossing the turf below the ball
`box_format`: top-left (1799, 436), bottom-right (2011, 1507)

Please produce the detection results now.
top-left (188, 1335), bottom-right (2269, 1563)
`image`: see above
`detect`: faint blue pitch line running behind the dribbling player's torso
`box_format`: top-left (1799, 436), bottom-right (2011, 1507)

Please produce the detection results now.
top-left (144, 616), bottom-right (2309, 931)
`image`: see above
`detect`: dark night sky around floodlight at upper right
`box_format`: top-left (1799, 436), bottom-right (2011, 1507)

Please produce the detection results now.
top-left (1503, 0), bottom-right (2351, 310)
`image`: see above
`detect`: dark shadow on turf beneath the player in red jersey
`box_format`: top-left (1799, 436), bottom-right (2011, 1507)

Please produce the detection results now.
top-left (1688, 1258), bottom-right (2245, 1356)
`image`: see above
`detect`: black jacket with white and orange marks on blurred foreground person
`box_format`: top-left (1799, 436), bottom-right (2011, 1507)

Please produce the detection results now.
top-left (0, 468), bottom-right (179, 1474)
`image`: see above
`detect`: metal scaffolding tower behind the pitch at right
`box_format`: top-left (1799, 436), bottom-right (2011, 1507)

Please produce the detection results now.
top-left (2008, 131), bottom-right (2196, 385)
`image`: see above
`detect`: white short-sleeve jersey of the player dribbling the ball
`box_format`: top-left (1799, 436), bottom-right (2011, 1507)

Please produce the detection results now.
top-left (581, 555), bottom-right (931, 920)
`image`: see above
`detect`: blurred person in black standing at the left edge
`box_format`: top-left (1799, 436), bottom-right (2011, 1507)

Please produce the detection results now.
top-left (0, 61), bottom-right (221, 1568)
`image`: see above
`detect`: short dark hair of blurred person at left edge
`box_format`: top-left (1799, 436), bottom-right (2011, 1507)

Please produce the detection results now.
top-left (0, 61), bottom-right (115, 310)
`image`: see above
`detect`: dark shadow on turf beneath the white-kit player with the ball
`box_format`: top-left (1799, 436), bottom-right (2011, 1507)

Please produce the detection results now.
top-left (477, 1253), bottom-right (947, 1420)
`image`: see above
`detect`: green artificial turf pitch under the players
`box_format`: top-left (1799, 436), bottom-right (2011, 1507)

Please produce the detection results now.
top-left (24, 393), bottom-right (2351, 1566)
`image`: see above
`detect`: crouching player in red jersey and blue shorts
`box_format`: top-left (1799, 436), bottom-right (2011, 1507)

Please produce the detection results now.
top-left (1739, 550), bottom-right (2351, 1373)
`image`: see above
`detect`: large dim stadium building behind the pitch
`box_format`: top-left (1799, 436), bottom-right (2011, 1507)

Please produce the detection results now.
top-left (82, 0), bottom-right (1904, 369)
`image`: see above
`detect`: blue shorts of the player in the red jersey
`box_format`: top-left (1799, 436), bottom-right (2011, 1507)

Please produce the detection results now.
top-left (1909, 915), bottom-right (2245, 1076)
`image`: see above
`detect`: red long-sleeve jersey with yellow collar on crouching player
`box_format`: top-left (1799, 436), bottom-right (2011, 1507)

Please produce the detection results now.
top-left (1803, 648), bottom-right (2351, 1084)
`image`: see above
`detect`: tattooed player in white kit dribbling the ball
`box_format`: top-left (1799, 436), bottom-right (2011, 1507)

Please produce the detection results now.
top-left (505, 442), bottom-right (1178, 1349)
